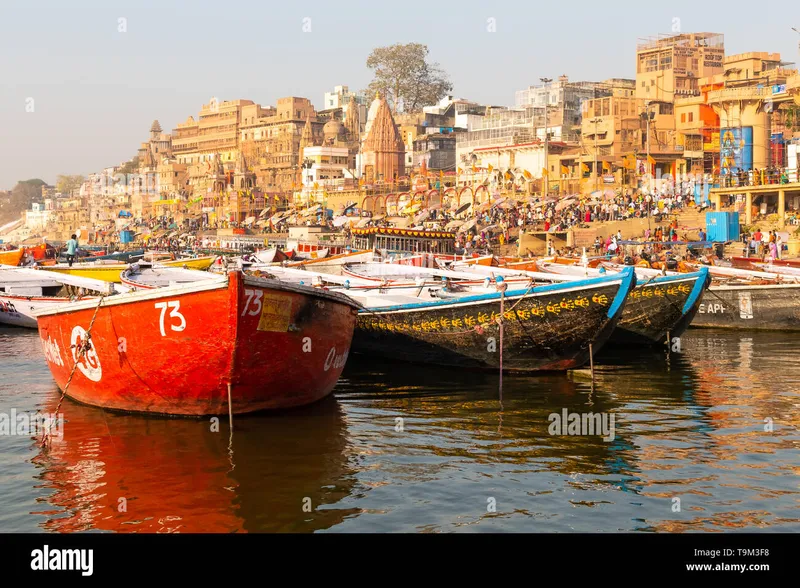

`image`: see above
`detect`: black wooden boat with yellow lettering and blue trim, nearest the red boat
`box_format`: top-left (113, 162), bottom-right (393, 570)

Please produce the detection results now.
top-left (349, 270), bottom-right (635, 372)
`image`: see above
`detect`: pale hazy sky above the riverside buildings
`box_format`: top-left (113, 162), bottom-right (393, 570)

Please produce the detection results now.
top-left (0, 0), bottom-right (800, 189)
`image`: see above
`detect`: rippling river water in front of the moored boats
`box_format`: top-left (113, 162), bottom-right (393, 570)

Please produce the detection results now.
top-left (0, 328), bottom-right (800, 533)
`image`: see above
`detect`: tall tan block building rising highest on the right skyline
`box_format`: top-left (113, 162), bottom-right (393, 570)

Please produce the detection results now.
top-left (636, 33), bottom-right (725, 102)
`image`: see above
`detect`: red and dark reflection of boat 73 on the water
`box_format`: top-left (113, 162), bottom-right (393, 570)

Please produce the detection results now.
top-left (35, 398), bottom-right (356, 533)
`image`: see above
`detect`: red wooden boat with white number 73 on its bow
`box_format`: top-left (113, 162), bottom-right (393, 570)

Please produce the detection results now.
top-left (37, 272), bottom-right (357, 416)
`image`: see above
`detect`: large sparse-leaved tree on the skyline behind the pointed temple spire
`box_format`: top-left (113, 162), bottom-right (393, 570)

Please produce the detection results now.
top-left (367, 43), bottom-right (453, 114)
